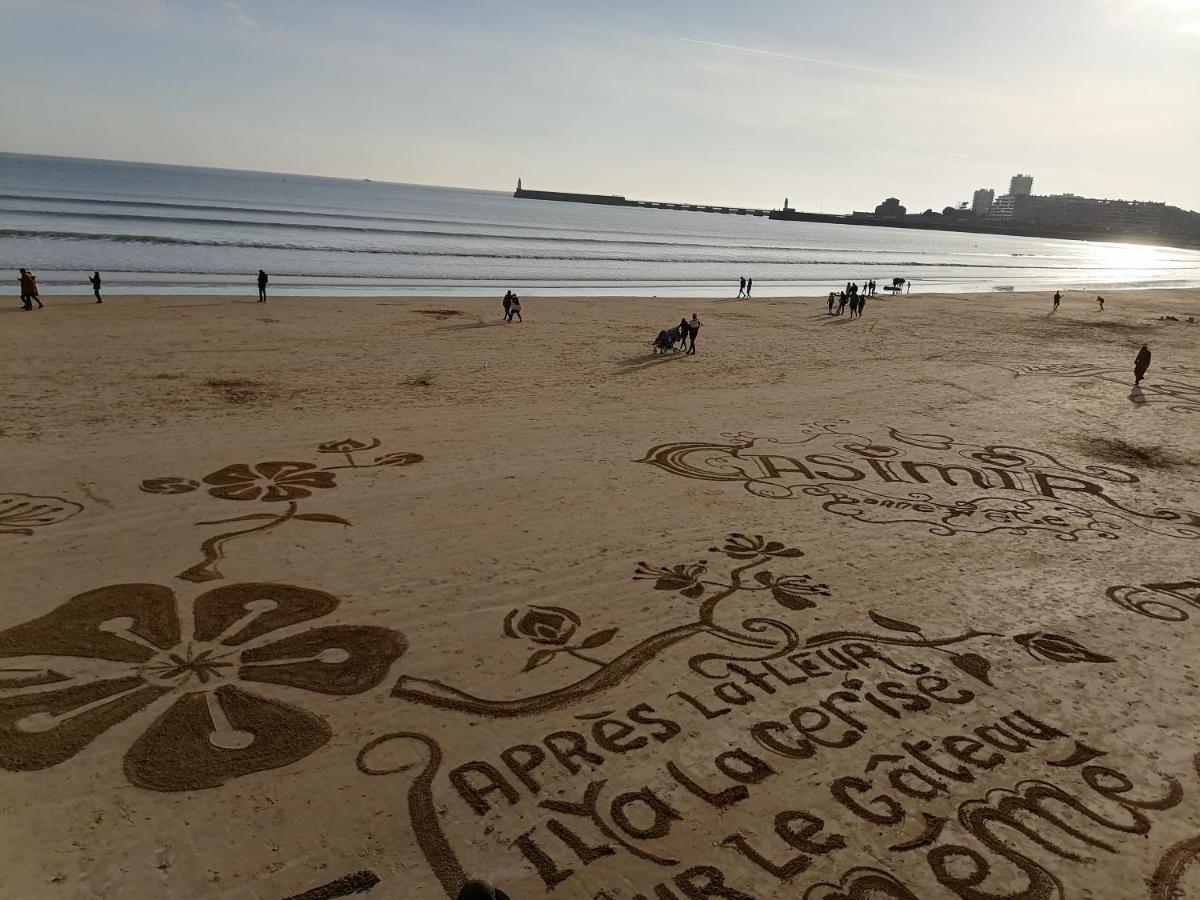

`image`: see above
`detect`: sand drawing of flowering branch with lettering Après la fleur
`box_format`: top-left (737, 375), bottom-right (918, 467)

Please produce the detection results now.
top-left (358, 533), bottom-right (1123, 900)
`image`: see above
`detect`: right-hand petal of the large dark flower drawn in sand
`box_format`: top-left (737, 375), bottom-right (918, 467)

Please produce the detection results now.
top-left (238, 625), bottom-right (408, 694)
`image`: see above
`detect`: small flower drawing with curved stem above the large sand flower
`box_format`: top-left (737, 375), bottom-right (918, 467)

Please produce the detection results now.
top-left (140, 438), bottom-right (425, 583)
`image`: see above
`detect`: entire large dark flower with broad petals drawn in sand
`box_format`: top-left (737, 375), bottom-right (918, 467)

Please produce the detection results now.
top-left (0, 583), bottom-right (406, 791)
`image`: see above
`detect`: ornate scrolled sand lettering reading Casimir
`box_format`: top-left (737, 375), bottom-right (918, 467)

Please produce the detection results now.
top-left (641, 422), bottom-right (1200, 541)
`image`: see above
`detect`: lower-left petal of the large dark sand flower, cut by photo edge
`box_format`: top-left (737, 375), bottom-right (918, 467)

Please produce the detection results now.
top-left (0, 676), bottom-right (169, 772)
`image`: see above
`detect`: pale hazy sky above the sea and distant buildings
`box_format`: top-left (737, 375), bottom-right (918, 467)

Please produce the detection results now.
top-left (0, 0), bottom-right (1200, 211)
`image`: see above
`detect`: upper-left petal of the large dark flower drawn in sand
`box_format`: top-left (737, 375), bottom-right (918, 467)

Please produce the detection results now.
top-left (0, 584), bottom-right (179, 662)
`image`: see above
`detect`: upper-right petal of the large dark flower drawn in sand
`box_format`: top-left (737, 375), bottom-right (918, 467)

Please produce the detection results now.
top-left (194, 583), bottom-right (337, 646)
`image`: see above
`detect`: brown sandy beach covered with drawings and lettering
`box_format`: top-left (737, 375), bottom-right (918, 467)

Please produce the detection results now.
top-left (0, 292), bottom-right (1200, 900)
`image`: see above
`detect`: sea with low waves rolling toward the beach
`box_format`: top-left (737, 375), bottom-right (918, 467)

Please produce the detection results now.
top-left (0, 154), bottom-right (1200, 296)
